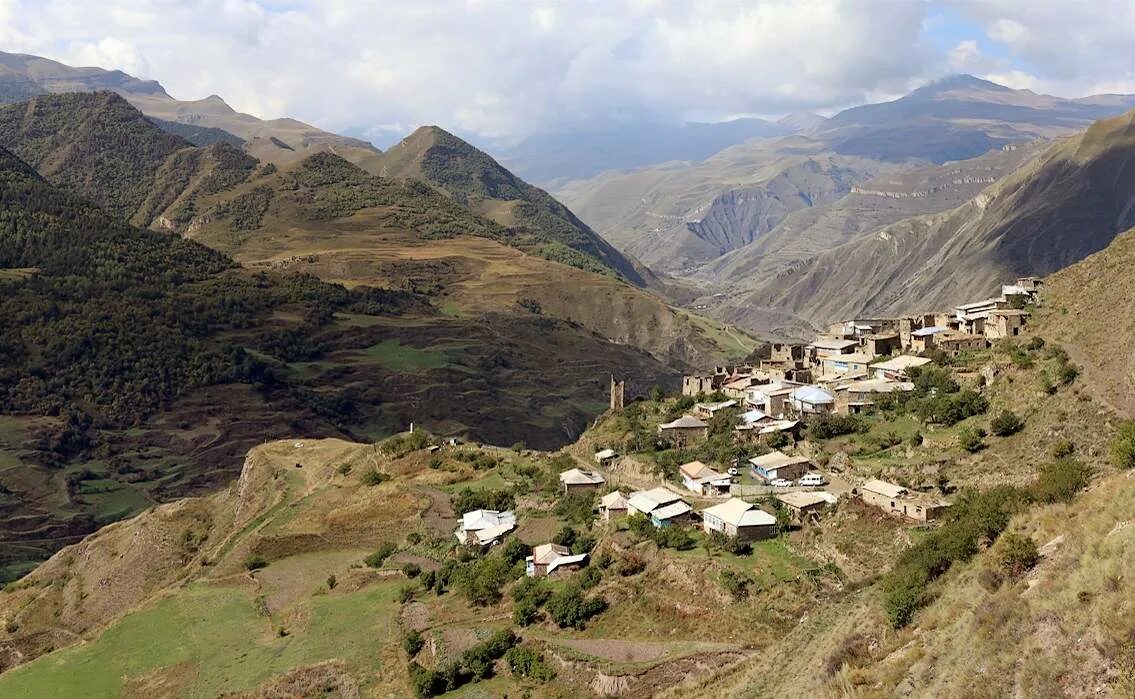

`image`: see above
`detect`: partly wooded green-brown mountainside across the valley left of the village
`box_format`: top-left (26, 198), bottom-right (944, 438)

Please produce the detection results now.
top-left (0, 74), bottom-right (757, 578)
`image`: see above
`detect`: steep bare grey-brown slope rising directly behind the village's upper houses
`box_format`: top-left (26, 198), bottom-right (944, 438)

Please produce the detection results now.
top-left (726, 112), bottom-right (1135, 333)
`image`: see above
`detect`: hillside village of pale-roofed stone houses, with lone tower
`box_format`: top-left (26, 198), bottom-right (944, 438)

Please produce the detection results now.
top-left (455, 277), bottom-right (1043, 576)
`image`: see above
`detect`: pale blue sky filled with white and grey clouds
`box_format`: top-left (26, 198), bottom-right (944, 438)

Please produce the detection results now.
top-left (0, 0), bottom-right (1135, 145)
